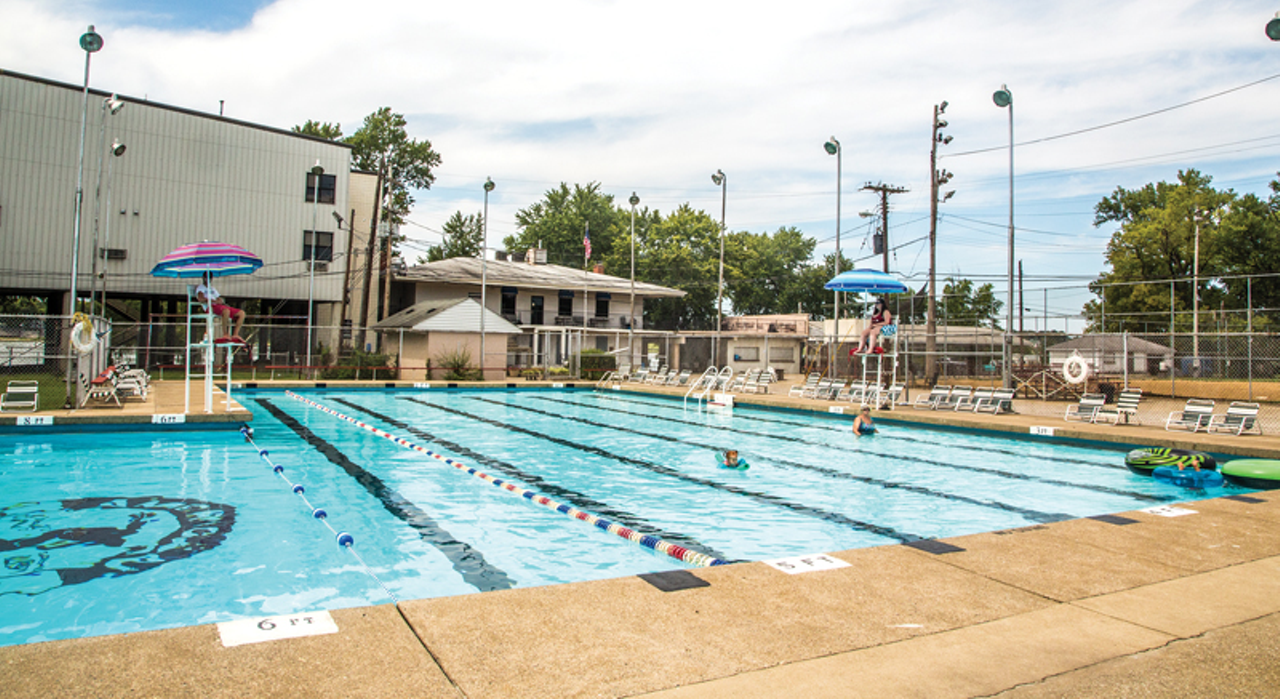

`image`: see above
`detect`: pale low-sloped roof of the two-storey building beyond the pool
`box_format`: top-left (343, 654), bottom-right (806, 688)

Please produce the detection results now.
top-left (396, 257), bottom-right (685, 298)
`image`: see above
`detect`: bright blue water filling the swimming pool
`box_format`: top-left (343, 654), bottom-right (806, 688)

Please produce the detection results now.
top-left (0, 389), bottom-right (1244, 645)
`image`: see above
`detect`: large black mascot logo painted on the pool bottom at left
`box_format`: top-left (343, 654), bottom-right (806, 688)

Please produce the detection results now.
top-left (0, 495), bottom-right (236, 595)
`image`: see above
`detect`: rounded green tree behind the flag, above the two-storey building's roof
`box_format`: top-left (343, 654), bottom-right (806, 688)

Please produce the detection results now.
top-left (503, 182), bottom-right (631, 268)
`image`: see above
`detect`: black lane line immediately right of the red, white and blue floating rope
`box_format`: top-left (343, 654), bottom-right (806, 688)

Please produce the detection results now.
top-left (329, 398), bottom-right (737, 563)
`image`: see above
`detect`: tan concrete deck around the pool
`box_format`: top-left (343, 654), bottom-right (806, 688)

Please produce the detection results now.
top-left (0, 383), bottom-right (1280, 699)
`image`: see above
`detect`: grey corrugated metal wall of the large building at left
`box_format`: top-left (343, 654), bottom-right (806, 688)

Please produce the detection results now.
top-left (0, 73), bottom-right (351, 301)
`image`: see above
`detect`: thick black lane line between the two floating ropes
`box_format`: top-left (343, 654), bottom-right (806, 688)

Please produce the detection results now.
top-left (255, 398), bottom-right (516, 593)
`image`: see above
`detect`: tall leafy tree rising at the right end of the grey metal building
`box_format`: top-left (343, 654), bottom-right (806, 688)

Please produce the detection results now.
top-left (347, 106), bottom-right (440, 347)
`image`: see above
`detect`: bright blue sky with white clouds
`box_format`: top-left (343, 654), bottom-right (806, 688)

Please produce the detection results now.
top-left (0, 0), bottom-right (1280, 329)
